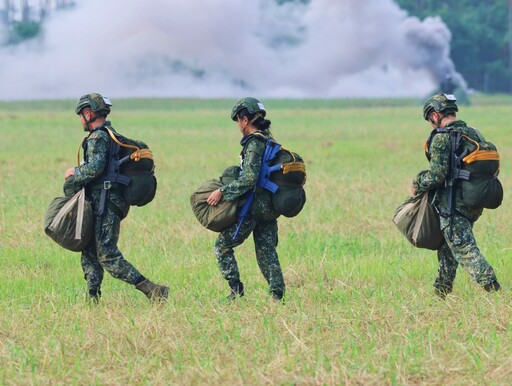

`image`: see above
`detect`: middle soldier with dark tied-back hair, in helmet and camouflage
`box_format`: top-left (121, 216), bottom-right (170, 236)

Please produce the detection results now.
top-left (207, 98), bottom-right (285, 300)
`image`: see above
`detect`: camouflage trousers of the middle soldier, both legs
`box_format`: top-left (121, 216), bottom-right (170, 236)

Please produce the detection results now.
top-left (215, 216), bottom-right (285, 294)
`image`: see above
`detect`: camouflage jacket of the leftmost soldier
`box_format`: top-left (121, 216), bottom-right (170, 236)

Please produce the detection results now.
top-left (74, 121), bottom-right (129, 215)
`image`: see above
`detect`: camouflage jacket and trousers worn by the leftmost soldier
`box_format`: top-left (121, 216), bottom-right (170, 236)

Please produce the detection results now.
top-left (74, 121), bottom-right (142, 296)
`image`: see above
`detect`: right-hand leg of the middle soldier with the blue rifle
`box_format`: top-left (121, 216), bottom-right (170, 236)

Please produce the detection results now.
top-left (253, 220), bottom-right (286, 300)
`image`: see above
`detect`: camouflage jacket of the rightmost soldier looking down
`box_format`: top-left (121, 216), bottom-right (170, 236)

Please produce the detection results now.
top-left (412, 120), bottom-right (482, 221)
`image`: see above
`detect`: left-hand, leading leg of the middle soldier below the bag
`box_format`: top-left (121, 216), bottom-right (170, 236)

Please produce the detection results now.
top-left (215, 217), bottom-right (255, 299)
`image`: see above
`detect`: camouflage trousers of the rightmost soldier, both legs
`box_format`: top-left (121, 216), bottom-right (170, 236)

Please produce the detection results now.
top-left (434, 213), bottom-right (497, 293)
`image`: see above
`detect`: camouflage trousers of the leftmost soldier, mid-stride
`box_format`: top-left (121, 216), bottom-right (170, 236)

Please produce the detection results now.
top-left (81, 208), bottom-right (141, 294)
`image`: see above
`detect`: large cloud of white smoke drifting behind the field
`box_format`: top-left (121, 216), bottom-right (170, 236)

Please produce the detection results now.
top-left (0, 0), bottom-right (463, 100)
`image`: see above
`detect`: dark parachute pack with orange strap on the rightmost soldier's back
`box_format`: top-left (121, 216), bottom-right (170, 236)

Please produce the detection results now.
top-left (425, 128), bottom-right (503, 209)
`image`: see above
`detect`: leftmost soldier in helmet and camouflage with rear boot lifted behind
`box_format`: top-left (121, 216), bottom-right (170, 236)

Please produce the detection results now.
top-left (64, 93), bottom-right (169, 302)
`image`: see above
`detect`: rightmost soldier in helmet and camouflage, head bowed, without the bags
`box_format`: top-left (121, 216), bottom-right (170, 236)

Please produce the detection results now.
top-left (411, 94), bottom-right (500, 298)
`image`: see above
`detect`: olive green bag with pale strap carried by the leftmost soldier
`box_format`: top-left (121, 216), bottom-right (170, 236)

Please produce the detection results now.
top-left (44, 189), bottom-right (94, 252)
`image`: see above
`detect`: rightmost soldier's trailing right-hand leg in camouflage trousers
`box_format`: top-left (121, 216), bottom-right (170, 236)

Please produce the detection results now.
top-left (441, 214), bottom-right (497, 289)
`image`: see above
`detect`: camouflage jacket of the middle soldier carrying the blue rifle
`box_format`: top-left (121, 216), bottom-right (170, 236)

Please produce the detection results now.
top-left (220, 131), bottom-right (279, 220)
